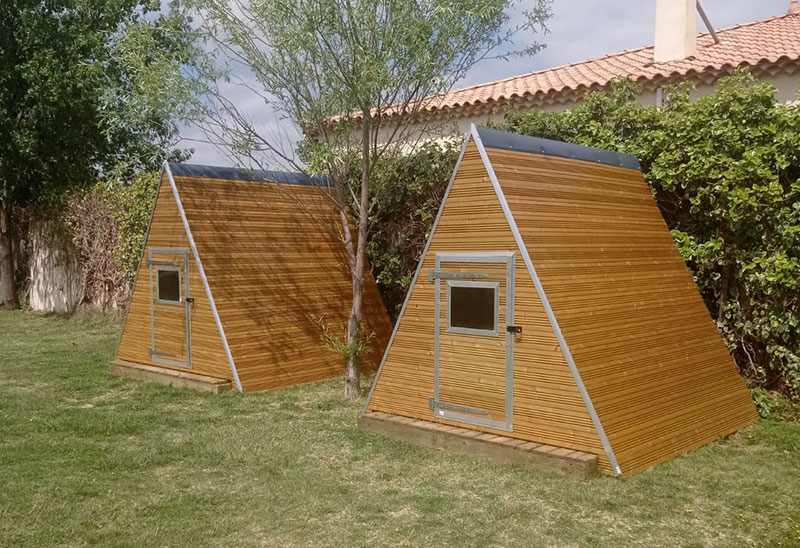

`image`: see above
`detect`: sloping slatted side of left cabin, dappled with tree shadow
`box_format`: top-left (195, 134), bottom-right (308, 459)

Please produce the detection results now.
top-left (175, 173), bottom-right (391, 391)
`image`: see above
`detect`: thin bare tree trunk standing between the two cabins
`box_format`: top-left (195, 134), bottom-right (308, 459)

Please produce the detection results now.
top-left (344, 113), bottom-right (371, 401)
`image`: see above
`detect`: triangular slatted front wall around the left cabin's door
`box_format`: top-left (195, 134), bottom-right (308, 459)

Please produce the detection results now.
top-left (117, 177), bottom-right (231, 379)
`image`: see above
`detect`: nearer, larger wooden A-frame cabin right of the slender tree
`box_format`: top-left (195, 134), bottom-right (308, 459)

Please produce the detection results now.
top-left (360, 126), bottom-right (758, 476)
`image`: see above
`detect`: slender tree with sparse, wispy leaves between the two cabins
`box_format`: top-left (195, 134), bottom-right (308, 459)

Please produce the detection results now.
top-left (195, 0), bottom-right (550, 399)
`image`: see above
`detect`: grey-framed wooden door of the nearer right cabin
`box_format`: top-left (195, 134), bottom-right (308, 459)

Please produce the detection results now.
top-left (428, 252), bottom-right (517, 431)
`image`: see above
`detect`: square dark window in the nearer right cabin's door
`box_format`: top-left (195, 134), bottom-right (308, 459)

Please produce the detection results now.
top-left (447, 282), bottom-right (498, 335)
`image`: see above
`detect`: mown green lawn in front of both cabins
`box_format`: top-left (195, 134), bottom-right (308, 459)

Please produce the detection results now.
top-left (0, 310), bottom-right (800, 547)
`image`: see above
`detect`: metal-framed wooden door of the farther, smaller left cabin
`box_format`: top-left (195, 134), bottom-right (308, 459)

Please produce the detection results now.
top-left (147, 247), bottom-right (192, 368)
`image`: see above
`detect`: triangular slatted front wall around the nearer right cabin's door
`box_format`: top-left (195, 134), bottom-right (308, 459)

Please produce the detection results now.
top-left (368, 143), bottom-right (610, 470)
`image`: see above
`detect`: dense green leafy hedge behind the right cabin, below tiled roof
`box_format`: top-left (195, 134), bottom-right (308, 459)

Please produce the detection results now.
top-left (505, 71), bottom-right (800, 397)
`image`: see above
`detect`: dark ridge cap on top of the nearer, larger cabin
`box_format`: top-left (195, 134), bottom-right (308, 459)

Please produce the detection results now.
top-left (476, 127), bottom-right (641, 171)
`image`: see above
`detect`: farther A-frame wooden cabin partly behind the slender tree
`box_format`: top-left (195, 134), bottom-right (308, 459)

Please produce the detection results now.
top-left (111, 163), bottom-right (391, 391)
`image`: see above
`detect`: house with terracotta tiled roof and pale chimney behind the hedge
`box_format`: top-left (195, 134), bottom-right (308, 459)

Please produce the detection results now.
top-left (404, 0), bottom-right (800, 139)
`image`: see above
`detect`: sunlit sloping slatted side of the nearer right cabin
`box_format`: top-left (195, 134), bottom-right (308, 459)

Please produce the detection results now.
top-left (487, 149), bottom-right (758, 475)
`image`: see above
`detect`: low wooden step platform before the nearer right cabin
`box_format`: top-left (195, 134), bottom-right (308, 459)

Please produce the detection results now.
top-left (358, 412), bottom-right (597, 479)
